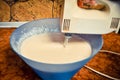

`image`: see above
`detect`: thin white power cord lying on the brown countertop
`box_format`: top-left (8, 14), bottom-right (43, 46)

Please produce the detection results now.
top-left (84, 50), bottom-right (120, 80)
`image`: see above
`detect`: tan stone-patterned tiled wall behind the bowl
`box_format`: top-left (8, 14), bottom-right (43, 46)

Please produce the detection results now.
top-left (0, 0), bottom-right (64, 22)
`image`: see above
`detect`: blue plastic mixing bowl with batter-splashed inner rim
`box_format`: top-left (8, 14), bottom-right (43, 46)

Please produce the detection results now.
top-left (10, 19), bottom-right (103, 80)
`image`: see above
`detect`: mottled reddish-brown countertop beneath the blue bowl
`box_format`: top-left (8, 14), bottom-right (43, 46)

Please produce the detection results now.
top-left (0, 28), bottom-right (120, 80)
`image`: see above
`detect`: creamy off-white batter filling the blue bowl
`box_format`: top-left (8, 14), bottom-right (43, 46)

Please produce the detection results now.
top-left (21, 33), bottom-right (91, 64)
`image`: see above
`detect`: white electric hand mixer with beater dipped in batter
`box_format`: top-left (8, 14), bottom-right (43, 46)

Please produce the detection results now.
top-left (61, 0), bottom-right (120, 46)
